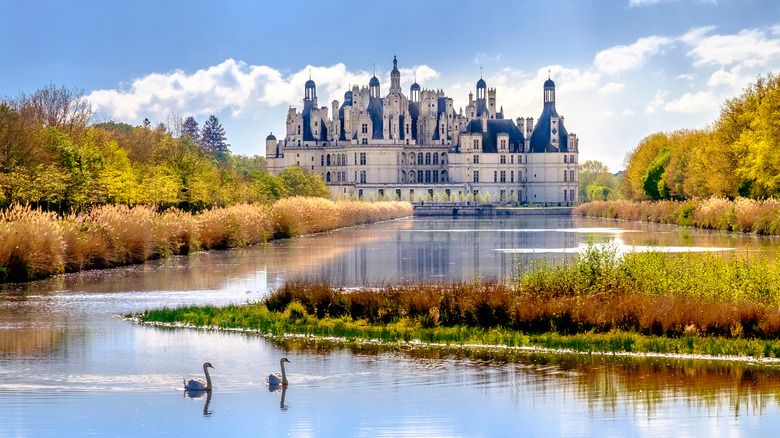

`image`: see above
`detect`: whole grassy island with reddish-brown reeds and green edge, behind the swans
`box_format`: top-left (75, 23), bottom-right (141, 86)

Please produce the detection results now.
top-left (133, 245), bottom-right (780, 358)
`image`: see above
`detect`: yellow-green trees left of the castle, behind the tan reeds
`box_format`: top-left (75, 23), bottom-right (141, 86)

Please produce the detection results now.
top-left (0, 83), bottom-right (329, 212)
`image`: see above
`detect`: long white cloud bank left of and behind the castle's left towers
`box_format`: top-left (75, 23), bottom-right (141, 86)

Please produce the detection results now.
top-left (87, 59), bottom-right (439, 123)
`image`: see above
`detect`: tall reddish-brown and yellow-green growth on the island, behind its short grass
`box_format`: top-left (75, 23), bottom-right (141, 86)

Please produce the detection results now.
top-left (264, 245), bottom-right (780, 339)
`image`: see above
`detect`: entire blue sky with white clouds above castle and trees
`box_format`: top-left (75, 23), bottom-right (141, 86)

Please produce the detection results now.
top-left (0, 0), bottom-right (780, 171)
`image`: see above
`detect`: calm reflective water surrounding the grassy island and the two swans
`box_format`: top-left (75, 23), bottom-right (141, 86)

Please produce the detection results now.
top-left (0, 217), bottom-right (780, 437)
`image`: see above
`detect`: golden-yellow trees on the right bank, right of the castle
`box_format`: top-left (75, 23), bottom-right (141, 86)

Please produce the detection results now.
top-left (620, 73), bottom-right (780, 200)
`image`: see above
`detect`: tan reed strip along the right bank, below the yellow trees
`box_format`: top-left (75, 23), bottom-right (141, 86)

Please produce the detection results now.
top-left (572, 197), bottom-right (780, 235)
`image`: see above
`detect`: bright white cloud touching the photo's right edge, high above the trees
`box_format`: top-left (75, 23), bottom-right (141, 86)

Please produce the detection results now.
top-left (680, 26), bottom-right (780, 67)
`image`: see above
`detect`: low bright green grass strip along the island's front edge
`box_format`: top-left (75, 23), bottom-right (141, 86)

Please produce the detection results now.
top-left (133, 303), bottom-right (780, 358)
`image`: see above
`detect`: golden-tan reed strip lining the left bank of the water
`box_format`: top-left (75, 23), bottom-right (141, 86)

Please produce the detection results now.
top-left (0, 197), bottom-right (412, 282)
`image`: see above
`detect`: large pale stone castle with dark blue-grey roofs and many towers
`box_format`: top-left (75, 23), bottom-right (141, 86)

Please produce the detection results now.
top-left (266, 57), bottom-right (578, 205)
